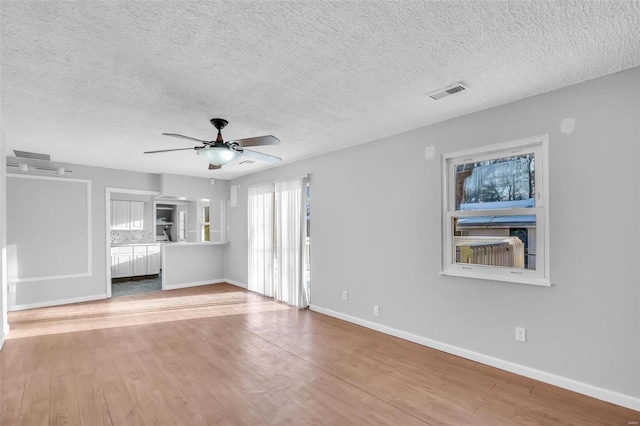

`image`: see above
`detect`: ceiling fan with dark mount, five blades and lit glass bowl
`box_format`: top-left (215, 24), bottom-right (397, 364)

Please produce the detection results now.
top-left (145, 118), bottom-right (282, 170)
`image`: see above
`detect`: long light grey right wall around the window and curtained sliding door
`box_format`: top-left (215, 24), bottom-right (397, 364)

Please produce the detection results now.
top-left (226, 68), bottom-right (640, 409)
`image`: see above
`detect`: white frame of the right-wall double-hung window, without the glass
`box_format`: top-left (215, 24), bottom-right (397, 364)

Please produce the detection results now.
top-left (441, 135), bottom-right (551, 287)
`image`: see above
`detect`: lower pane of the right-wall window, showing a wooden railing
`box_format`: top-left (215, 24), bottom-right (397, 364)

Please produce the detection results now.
top-left (452, 215), bottom-right (536, 270)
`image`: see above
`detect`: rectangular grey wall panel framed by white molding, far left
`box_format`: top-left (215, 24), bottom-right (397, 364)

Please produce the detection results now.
top-left (7, 175), bottom-right (91, 282)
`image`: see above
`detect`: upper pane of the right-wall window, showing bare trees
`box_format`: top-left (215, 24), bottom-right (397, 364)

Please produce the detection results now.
top-left (454, 153), bottom-right (535, 210)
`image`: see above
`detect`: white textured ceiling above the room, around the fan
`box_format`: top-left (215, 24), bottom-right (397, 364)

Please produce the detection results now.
top-left (0, 0), bottom-right (640, 179)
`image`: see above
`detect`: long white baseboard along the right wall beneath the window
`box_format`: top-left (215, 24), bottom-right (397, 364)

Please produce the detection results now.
top-left (309, 305), bottom-right (640, 411)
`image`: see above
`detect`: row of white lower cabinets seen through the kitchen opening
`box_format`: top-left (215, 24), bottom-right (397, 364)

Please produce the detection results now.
top-left (111, 244), bottom-right (160, 278)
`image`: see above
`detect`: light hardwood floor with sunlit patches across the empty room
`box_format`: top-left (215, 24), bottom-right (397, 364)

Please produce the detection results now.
top-left (0, 284), bottom-right (640, 426)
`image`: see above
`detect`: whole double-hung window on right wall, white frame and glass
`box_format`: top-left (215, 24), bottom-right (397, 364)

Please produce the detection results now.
top-left (442, 136), bottom-right (550, 286)
